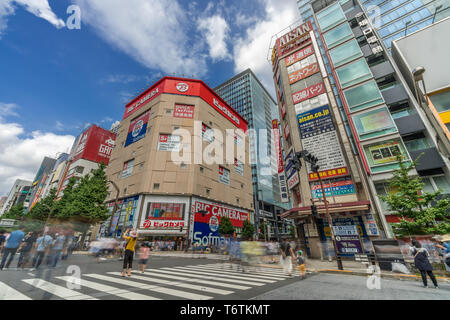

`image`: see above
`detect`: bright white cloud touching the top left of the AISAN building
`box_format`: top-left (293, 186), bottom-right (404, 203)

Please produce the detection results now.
top-left (233, 0), bottom-right (300, 97)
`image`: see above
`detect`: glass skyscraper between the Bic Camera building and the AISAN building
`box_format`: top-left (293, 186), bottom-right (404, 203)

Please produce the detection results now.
top-left (214, 69), bottom-right (290, 237)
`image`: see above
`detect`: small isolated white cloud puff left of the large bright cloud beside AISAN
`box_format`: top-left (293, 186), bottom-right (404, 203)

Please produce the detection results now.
top-left (198, 15), bottom-right (231, 60)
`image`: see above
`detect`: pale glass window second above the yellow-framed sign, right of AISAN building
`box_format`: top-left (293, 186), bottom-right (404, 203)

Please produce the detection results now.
top-left (344, 80), bottom-right (384, 112)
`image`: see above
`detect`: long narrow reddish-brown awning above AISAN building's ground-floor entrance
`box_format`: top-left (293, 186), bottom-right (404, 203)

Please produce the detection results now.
top-left (280, 200), bottom-right (370, 219)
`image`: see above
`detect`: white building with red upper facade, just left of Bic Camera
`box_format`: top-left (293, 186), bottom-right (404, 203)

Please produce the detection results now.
top-left (54, 124), bottom-right (116, 197)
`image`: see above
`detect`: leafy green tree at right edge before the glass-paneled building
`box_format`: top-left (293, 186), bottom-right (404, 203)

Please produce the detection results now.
top-left (380, 155), bottom-right (450, 237)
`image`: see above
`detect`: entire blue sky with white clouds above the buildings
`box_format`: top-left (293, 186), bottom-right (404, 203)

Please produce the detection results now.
top-left (0, 0), bottom-right (299, 195)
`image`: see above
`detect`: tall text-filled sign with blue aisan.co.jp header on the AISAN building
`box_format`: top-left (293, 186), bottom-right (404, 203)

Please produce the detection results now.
top-left (297, 105), bottom-right (348, 181)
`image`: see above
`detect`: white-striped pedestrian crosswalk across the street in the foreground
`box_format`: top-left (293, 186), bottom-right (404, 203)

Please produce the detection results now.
top-left (0, 263), bottom-right (300, 300)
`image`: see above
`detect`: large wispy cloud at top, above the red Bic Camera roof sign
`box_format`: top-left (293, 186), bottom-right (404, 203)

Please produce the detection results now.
top-left (76, 0), bottom-right (206, 76)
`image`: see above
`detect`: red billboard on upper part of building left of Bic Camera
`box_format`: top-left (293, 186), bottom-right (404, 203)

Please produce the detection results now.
top-left (72, 125), bottom-right (116, 165)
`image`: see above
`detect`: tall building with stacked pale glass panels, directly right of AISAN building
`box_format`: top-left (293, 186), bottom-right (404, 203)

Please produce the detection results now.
top-left (292, 0), bottom-right (450, 236)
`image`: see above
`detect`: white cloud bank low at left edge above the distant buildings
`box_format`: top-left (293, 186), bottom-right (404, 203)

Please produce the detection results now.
top-left (0, 105), bottom-right (75, 195)
